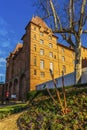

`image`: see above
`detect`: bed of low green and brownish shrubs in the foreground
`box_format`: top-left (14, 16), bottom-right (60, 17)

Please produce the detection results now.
top-left (20, 87), bottom-right (87, 130)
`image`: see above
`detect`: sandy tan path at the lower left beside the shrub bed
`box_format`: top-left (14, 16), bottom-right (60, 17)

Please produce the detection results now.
top-left (0, 112), bottom-right (23, 130)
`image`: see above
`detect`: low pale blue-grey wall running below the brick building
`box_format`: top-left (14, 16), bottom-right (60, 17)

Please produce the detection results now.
top-left (36, 67), bottom-right (87, 90)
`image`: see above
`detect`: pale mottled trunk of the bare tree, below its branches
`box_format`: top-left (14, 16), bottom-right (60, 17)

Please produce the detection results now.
top-left (75, 40), bottom-right (82, 84)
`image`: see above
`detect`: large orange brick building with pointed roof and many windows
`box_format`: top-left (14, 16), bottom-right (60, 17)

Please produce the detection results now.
top-left (6, 16), bottom-right (87, 99)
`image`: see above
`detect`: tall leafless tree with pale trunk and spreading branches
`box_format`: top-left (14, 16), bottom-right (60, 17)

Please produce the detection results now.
top-left (36, 0), bottom-right (87, 84)
